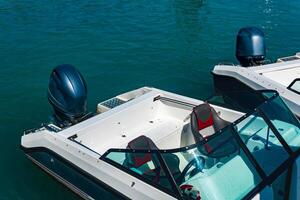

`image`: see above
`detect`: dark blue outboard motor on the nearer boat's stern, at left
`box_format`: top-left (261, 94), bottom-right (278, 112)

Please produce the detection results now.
top-left (48, 64), bottom-right (87, 127)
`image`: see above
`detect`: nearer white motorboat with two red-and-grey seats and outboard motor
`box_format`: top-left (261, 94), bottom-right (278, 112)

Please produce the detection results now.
top-left (21, 65), bottom-right (300, 200)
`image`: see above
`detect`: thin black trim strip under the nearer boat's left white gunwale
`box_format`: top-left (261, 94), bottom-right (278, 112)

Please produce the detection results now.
top-left (20, 145), bottom-right (130, 199)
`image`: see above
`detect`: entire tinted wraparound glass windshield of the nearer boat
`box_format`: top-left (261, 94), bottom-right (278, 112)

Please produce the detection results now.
top-left (102, 95), bottom-right (300, 200)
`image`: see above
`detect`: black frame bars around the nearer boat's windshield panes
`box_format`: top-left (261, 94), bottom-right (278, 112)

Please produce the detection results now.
top-left (100, 91), bottom-right (300, 199)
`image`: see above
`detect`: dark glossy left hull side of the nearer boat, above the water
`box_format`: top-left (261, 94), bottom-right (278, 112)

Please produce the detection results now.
top-left (22, 147), bottom-right (128, 200)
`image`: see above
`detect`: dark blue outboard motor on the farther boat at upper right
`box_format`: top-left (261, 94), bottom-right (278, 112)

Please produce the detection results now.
top-left (235, 27), bottom-right (266, 67)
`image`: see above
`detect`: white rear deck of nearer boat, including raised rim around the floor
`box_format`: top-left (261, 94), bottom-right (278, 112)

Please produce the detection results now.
top-left (59, 89), bottom-right (242, 154)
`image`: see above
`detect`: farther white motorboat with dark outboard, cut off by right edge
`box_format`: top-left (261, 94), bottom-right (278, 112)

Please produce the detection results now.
top-left (212, 27), bottom-right (300, 117)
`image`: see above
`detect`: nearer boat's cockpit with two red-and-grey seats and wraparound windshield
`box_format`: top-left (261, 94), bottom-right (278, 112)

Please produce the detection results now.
top-left (101, 93), bottom-right (300, 200)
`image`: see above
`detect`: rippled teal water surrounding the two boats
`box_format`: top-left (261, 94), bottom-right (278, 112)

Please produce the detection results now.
top-left (0, 0), bottom-right (300, 200)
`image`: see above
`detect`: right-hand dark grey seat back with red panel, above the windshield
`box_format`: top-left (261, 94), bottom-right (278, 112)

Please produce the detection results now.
top-left (191, 103), bottom-right (230, 142)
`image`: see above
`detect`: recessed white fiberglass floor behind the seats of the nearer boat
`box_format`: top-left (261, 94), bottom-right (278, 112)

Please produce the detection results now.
top-left (72, 96), bottom-right (191, 154)
